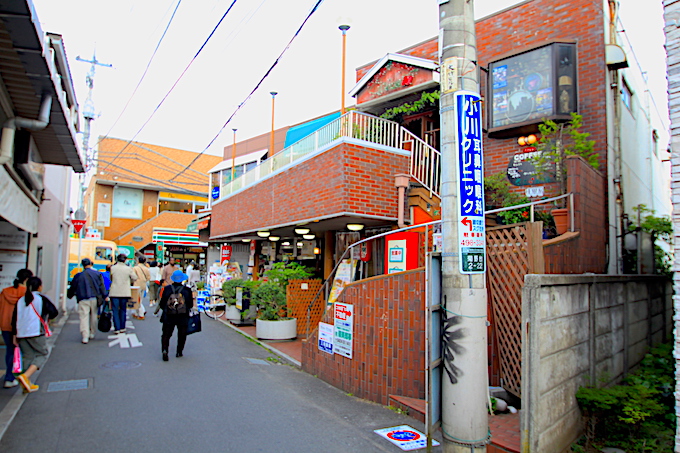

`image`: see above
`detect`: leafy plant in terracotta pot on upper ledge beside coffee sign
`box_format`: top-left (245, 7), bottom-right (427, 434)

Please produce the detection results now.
top-left (533, 112), bottom-right (600, 234)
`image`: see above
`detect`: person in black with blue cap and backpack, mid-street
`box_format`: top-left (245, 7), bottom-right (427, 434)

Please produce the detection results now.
top-left (159, 270), bottom-right (194, 362)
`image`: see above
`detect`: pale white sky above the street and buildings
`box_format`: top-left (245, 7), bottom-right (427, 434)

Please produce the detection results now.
top-left (33, 0), bottom-right (666, 162)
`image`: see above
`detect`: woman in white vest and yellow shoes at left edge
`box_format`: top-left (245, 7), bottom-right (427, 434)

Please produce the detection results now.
top-left (12, 277), bottom-right (58, 393)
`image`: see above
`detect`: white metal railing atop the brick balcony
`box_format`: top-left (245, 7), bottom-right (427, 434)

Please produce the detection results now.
top-left (215, 111), bottom-right (440, 198)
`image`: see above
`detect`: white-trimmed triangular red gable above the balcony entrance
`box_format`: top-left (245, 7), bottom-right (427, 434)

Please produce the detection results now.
top-left (349, 53), bottom-right (439, 105)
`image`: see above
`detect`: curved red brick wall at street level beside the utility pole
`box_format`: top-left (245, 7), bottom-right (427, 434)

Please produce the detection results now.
top-left (302, 269), bottom-right (425, 405)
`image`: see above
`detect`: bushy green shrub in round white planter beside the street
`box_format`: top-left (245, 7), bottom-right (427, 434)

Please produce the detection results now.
top-left (252, 282), bottom-right (297, 340)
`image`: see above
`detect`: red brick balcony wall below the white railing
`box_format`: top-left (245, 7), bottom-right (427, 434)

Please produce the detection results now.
top-left (211, 143), bottom-right (409, 237)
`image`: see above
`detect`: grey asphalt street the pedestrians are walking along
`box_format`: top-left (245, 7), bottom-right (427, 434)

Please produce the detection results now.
top-left (0, 304), bottom-right (441, 453)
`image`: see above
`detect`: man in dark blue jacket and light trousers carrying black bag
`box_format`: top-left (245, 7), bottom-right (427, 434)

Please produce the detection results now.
top-left (66, 258), bottom-right (109, 344)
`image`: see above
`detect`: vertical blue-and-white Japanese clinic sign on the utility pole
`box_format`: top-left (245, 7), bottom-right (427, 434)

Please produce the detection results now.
top-left (454, 91), bottom-right (486, 274)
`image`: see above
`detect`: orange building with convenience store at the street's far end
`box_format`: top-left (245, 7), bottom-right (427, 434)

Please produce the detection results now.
top-left (85, 137), bottom-right (221, 263)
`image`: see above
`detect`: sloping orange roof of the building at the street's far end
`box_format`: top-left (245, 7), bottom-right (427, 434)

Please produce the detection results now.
top-left (95, 137), bottom-right (222, 196)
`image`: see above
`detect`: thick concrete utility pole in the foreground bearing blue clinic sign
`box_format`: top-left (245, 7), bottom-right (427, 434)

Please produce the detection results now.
top-left (439, 0), bottom-right (489, 453)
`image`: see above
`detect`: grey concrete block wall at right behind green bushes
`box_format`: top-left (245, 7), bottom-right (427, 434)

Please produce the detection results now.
top-left (521, 275), bottom-right (673, 453)
